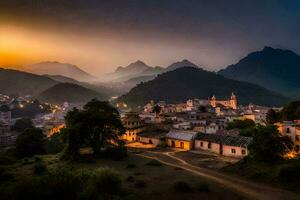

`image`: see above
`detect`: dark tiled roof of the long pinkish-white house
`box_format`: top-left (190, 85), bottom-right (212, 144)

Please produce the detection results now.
top-left (196, 133), bottom-right (252, 147)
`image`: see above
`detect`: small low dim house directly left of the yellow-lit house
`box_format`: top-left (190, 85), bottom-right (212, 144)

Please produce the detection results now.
top-left (137, 131), bottom-right (166, 147)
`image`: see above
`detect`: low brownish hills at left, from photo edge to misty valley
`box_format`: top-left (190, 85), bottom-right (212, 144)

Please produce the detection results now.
top-left (0, 68), bottom-right (110, 103)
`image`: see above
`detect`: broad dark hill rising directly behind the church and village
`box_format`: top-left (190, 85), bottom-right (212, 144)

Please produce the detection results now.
top-left (118, 67), bottom-right (289, 106)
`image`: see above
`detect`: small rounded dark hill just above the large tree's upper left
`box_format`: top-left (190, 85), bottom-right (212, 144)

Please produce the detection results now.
top-left (36, 83), bottom-right (103, 103)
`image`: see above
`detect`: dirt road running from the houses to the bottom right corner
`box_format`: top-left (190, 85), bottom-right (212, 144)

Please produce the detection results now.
top-left (136, 151), bottom-right (300, 200)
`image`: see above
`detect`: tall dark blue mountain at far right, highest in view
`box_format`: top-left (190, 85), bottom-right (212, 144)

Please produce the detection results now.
top-left (218, 47), bottom-right (300, 94)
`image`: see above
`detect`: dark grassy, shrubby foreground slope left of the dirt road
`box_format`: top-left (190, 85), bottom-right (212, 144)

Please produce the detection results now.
top-left (0, 152), bottom-right (246, 200)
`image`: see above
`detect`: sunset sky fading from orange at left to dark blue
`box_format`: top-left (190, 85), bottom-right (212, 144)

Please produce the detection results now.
top-left (0, 0), bottom-right (300, 76)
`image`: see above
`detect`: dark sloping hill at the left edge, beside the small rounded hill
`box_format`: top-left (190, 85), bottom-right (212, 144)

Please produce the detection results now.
top-left (0, 68), bottom-right (58, 95)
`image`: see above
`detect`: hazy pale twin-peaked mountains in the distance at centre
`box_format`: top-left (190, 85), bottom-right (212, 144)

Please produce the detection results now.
top-left (108, 59), bottom-right (198, 82)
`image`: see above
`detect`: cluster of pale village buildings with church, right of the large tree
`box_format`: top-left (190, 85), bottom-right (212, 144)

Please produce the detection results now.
top-left (117, 93), bottom-right (300, 159)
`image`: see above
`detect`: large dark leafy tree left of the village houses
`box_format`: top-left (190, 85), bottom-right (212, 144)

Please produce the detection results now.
top-left (62, 99), bottom-right (124, 159)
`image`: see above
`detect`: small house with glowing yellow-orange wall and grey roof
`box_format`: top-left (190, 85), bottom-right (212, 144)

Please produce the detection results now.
top-left (166, 130), bottom-right (197, 150)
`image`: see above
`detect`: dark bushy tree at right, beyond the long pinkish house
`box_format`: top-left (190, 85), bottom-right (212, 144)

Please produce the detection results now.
top-left (249, 125), bottom-right (293, 162)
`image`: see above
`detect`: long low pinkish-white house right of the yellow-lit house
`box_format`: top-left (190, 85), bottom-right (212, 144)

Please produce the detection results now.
top-left (195, 133), bottom-right (252, 157)
